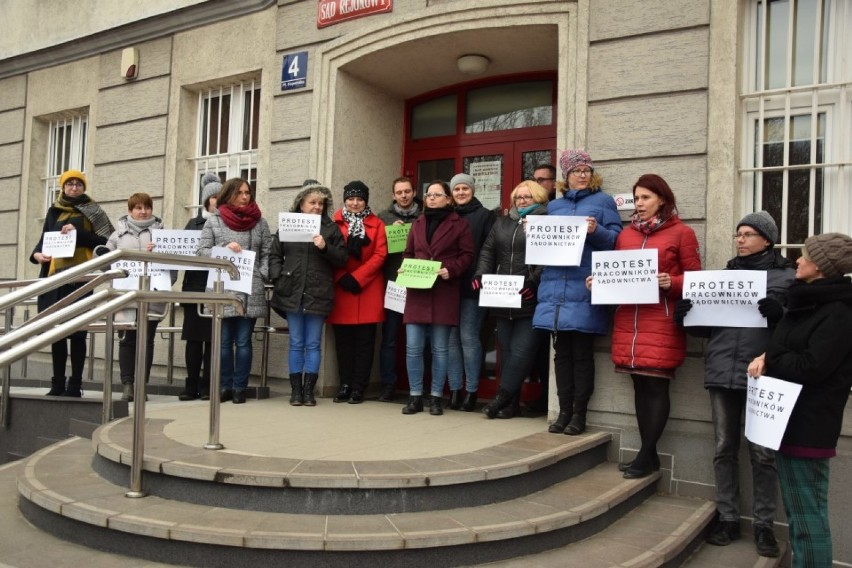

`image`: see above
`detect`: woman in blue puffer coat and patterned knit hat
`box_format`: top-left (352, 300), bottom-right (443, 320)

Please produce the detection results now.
top-left (533, 150), bottom-right (622, 436)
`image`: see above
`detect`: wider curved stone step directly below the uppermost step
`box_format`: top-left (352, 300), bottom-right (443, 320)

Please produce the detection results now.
top-left (17, 436), bottom-right (676, 568)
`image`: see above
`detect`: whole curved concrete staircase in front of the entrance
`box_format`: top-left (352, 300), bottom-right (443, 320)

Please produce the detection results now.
top-left (17, 412), bottom-right (714, 568)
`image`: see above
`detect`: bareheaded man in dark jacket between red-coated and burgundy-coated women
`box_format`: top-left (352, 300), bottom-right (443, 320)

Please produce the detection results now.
top-left (379, 177), bottom-right (423, 402)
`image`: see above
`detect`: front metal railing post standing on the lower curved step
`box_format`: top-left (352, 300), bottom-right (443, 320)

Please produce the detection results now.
top-left (124, 270), bottom-right (151, 498)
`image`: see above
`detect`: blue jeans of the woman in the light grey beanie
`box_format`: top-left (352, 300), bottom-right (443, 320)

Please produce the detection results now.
top-left (448, 298), bottom-right (487, 392)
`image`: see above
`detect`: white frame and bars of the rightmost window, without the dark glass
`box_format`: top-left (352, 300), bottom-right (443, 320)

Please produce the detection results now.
top-left (740, 0), bottom-right (852, 252)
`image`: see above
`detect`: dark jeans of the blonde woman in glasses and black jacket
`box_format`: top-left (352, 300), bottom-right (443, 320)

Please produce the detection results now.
top-left (496, 317), bottom-right (541, 395)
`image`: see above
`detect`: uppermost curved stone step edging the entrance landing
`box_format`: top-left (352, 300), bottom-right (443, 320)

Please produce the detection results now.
top-left (92, 419), bottom-right (611, 514)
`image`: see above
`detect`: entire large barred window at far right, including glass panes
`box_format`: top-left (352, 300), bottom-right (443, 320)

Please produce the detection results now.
top-left (740, 0), bottom-right (852, 256)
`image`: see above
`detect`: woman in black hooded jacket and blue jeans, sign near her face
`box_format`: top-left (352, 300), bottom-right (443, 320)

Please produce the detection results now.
top-left (269, 180), bottom-right (348, 406)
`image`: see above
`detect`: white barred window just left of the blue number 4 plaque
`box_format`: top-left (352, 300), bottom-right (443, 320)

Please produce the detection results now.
top-left (188, 79), bottom-right (260, 209)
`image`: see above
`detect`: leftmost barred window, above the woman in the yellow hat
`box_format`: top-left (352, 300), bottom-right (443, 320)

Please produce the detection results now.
top-left (44, 113), bottom-right (89, 212)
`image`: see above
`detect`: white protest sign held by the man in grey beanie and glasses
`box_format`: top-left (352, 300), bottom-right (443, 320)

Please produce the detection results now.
top-left (683, 270), bottom-right (767, 327)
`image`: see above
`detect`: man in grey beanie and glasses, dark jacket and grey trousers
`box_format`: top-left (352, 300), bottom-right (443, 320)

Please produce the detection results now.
top-left (675, 211), bottom-right (796, 557)
